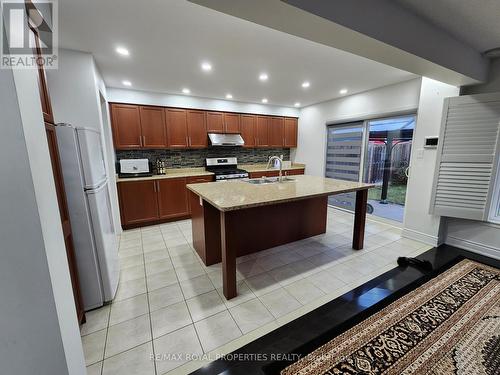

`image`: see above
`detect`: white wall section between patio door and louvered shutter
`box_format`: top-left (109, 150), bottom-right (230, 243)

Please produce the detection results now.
top-left (403, 77), bottom-right (459, 245)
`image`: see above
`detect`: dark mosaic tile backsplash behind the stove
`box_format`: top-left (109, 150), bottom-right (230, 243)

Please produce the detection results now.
top-left (116, 147), bottom-right (290, 168)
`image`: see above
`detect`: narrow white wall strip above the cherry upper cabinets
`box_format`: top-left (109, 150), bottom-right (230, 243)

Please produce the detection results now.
top-left (107, 87), bottom-right (299, 117)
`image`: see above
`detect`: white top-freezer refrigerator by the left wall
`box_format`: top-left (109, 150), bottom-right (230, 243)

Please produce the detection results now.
top-left (56, 124), bottom-right (120, 311)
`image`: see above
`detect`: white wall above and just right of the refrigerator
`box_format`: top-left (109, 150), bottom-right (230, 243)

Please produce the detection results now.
top-left (47, 49), bottom-right (122, 233)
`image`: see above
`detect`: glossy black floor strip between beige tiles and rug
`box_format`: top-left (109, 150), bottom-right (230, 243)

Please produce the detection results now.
top-left (189, 245), bottom-right (500, 375)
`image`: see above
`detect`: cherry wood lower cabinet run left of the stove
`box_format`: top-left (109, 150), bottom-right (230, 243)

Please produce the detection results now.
top-left (118, 176), bottom-right (213, 229)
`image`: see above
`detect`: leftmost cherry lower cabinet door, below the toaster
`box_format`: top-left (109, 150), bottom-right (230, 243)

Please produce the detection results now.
top-left (118, 180), bottom-right (158, 225)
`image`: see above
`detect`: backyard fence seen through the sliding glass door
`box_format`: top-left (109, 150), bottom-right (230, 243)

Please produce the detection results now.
top-left (365, 141), bottom-right (412, 184)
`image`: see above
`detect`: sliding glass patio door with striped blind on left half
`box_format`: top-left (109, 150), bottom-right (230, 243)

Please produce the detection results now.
top-left (325, 114), bottom-right (416, 222)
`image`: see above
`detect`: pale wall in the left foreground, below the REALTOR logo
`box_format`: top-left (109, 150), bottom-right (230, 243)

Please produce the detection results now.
top-left (0, 70), bottom-right (86, 375)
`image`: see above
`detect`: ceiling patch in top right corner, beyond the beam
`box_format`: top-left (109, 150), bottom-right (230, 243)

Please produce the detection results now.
top-left (397, 0), bottom-right (500, 52)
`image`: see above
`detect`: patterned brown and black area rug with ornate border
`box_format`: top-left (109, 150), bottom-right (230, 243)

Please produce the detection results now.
top-left (281, 260), bottom-right (500, 375)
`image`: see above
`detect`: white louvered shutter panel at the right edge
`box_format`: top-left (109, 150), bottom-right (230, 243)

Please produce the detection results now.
top-left (431, 97), bottom-right (500, 220)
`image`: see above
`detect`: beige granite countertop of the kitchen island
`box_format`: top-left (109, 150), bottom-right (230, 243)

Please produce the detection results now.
top-left (187, 175), bottom-right (375, 211)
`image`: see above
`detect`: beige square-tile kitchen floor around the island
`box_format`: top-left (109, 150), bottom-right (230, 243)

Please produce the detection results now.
top-left (81, 208), bottom-right (430, 375)
